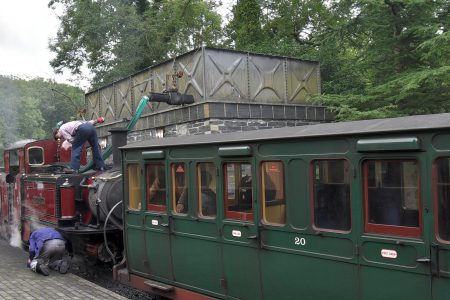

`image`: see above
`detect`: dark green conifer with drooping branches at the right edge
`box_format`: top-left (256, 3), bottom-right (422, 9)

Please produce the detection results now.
top-left (319, 0), bottom-right (450, 119)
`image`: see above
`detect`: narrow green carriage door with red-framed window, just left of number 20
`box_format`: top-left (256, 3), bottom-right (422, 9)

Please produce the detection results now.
top-left (222, 159), bottom-right (262, 299)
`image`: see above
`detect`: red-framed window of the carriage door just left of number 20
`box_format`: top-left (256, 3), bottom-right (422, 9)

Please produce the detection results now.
top-left (224, 163), bottom-right (253, 220)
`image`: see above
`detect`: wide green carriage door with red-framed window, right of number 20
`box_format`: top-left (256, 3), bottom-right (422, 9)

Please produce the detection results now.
top-left (360, 156), bottom-right (431, 300)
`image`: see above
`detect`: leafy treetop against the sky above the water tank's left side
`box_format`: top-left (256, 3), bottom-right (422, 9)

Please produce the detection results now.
top-left (49, 0), bottom-right (221, 87)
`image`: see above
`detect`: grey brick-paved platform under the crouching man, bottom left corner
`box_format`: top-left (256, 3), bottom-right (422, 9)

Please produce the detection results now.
top-left (0, 239), bottom-right (126, 300)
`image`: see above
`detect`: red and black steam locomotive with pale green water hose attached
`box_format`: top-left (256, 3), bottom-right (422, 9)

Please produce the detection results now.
top-left (0, 91), bottom-right (194, 263)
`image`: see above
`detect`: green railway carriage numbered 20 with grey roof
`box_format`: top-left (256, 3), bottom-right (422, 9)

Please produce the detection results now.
top-left (116, 114), bottom-right (450, 300)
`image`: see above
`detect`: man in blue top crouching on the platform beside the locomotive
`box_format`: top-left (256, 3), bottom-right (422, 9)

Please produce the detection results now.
top-left (28, 228), bottom-right (70, 276)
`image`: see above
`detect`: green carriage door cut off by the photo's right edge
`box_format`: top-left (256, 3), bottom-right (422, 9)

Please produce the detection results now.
top-left (431, 157), bottom-right (450, 300)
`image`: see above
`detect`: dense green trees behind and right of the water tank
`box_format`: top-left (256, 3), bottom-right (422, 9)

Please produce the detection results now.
top-left (228, 0), bottom-right (450, 120)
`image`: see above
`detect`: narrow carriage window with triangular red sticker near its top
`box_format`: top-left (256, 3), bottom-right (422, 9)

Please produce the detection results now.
top-left (172, 163), bottom-right (188, 214)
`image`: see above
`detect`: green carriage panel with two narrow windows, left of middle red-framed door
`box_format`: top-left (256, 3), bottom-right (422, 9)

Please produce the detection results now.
top-left (170, 162), bottom-right (224, 296)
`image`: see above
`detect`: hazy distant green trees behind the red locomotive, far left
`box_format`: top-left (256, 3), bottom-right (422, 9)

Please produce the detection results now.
top-left (0, 76), bottom-right (84, 148)
